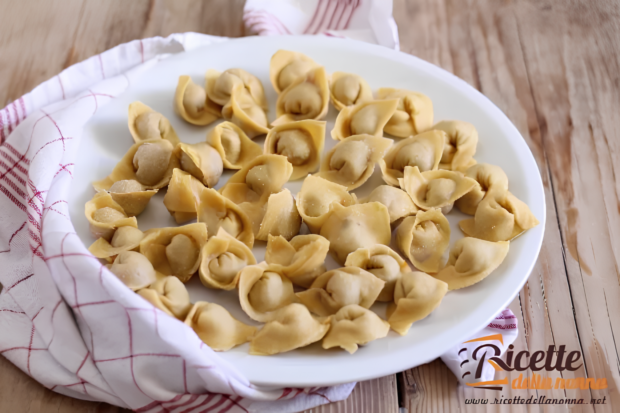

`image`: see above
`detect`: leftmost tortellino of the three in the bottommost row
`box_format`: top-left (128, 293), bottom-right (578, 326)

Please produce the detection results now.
top-left (185, 301), bottom-right (256, 351)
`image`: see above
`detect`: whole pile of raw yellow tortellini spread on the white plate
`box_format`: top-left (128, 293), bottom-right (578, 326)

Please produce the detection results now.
top-left (85, 50), bottom-right (538, 355)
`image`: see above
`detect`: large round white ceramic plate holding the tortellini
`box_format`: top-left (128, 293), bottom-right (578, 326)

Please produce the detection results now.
top-left (69, 36), bottom-right (545, 387)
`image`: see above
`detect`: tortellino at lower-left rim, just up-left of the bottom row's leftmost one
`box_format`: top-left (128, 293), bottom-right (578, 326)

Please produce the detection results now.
top-left (138, 275), bottom-right (192, 320)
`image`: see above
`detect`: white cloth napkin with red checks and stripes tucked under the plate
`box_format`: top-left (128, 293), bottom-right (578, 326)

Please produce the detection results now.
top-left (0, 0), bottom-right (512, 412)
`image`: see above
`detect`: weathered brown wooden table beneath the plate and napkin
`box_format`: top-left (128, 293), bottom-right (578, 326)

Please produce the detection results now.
top-left (0, 0), bottom-right (620, 413)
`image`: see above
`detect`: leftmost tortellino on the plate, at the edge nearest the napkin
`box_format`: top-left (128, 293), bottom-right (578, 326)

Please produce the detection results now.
top-left (84, 191), bottom-right (138, 241)
